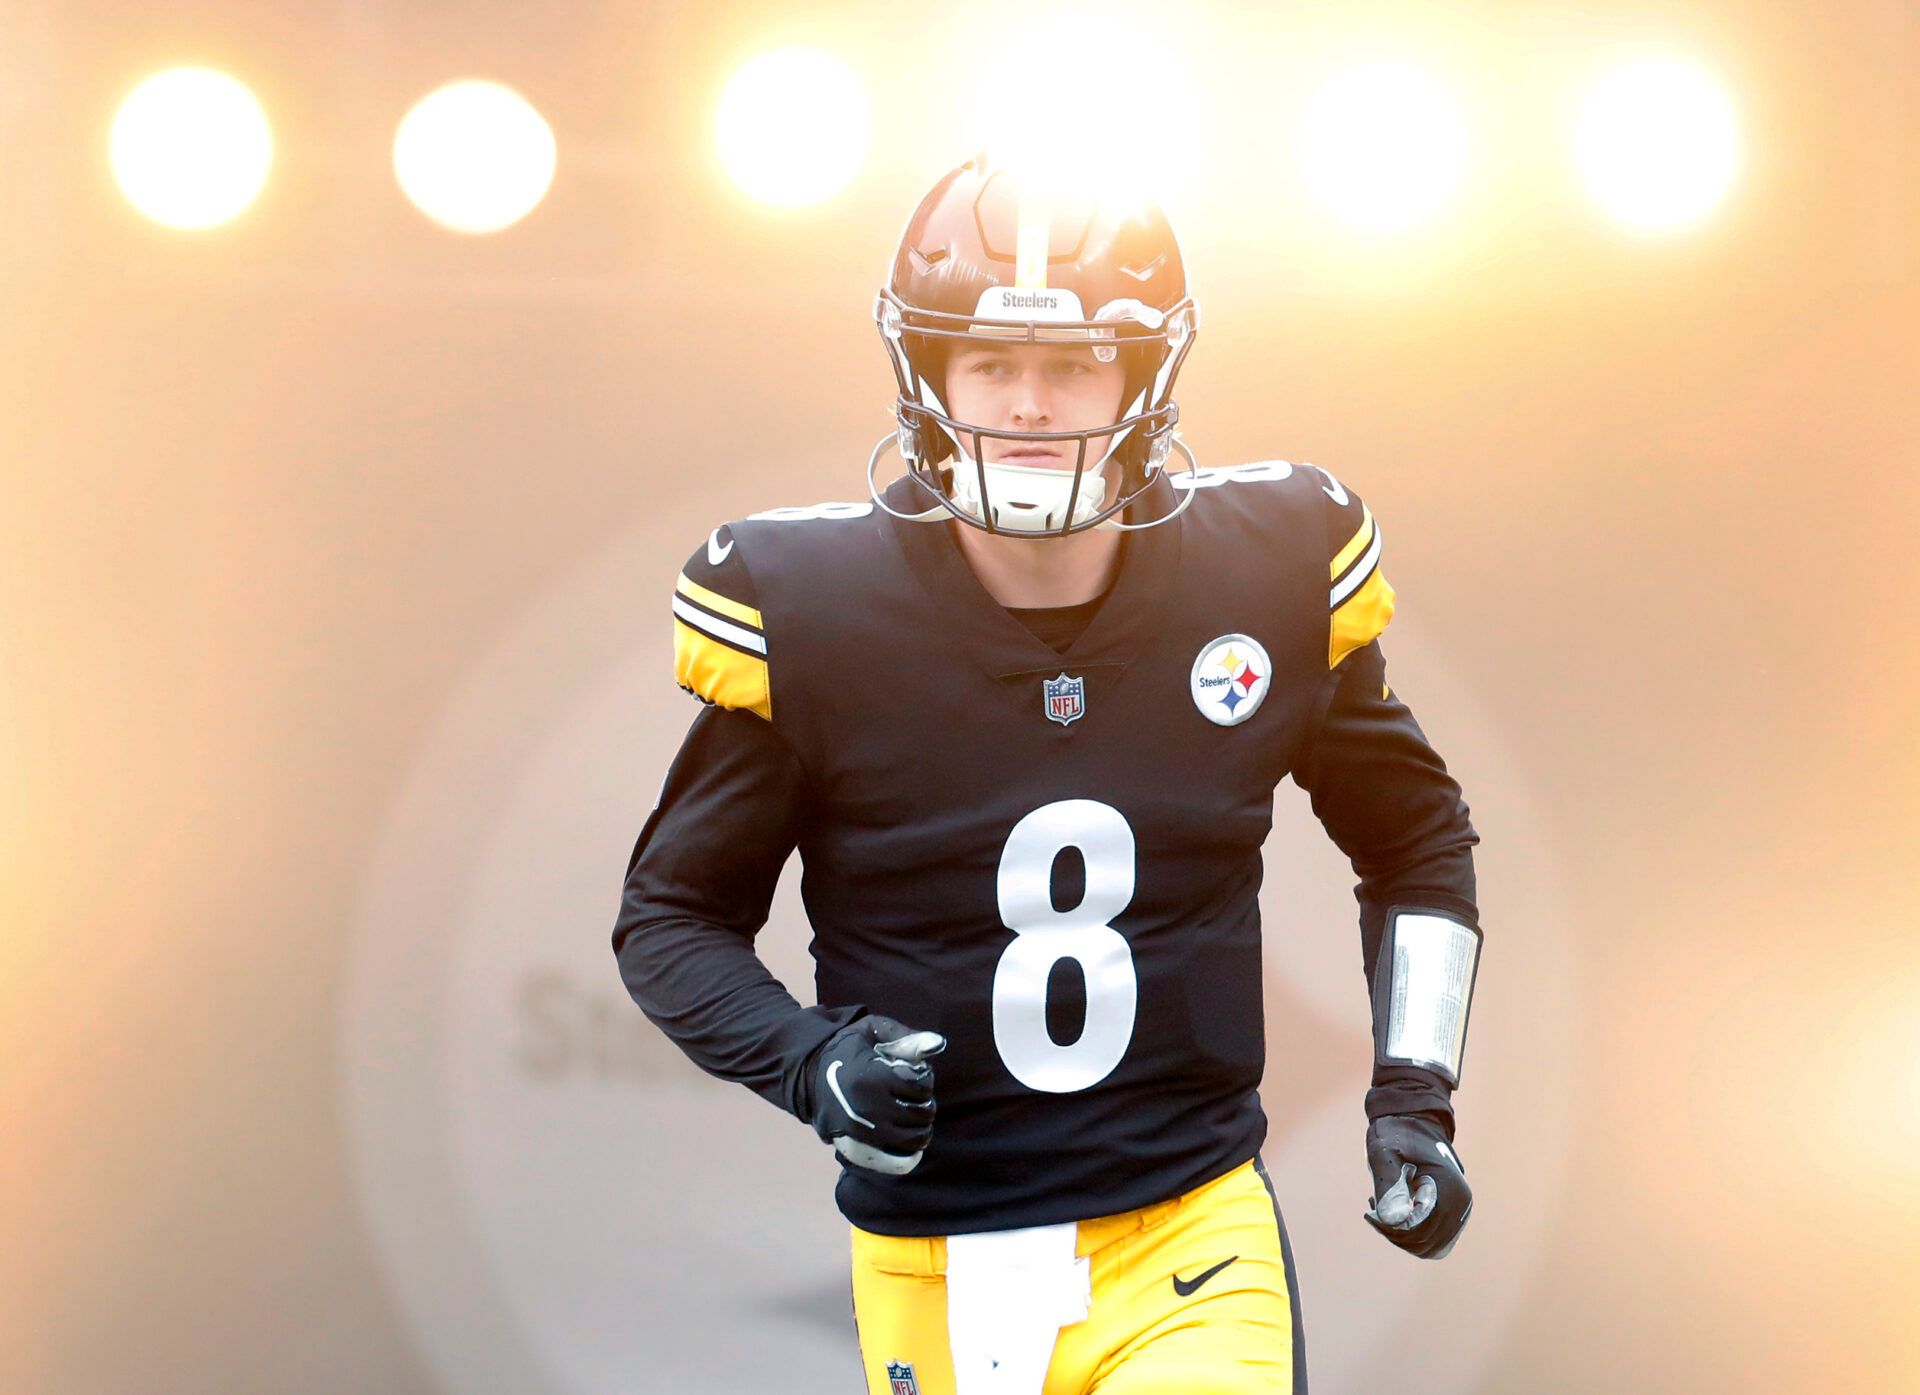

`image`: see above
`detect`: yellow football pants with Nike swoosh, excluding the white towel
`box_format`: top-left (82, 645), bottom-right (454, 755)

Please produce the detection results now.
top-left (852, 1159), bottom-right (1308, 1395)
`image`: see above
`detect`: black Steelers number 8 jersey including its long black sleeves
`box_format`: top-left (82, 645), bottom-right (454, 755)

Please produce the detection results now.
top-left (614, 462), bottom-right (1475, 1234)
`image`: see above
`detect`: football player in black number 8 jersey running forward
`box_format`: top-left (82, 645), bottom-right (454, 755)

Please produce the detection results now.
top-left (612, 159), bottom-right (1480, 1395)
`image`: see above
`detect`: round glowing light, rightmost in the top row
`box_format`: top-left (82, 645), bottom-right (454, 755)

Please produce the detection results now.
top-left (1576, 61), bottom-right (1740, 228)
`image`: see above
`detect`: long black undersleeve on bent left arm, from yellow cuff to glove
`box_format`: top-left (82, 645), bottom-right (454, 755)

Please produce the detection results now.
top-left (612, 706), bottom-right (864, 1117)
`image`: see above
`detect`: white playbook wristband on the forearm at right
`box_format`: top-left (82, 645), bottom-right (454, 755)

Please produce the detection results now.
top-left (1373, 906), bottom-right (1480, 1086)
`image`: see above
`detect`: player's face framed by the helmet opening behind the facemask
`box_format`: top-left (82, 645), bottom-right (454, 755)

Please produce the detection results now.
top-left (947, 343), bottom-right (1127, 470)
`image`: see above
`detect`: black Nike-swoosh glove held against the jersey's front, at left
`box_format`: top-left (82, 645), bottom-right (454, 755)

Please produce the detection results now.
top-left (808, 1015), bottom-right (947, 1176)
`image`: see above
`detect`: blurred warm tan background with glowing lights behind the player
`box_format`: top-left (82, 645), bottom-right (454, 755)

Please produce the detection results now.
top-left (0, 0), bottom-right (1920, 1395)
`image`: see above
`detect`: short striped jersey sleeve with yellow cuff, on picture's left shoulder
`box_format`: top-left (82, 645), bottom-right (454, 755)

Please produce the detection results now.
top-left (674, 524), bottom-right (774, 721)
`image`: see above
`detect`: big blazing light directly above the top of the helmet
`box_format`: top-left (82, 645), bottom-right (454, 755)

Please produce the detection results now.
top-left (968, 8), bottom-right (1202, 203)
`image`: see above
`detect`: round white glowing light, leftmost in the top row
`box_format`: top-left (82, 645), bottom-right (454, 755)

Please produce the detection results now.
top-left (108, 67), bottom-right (273, 228)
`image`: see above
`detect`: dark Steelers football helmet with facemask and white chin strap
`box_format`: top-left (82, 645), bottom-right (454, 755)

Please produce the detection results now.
top-left (868, 155), bottom-right (1200, 535)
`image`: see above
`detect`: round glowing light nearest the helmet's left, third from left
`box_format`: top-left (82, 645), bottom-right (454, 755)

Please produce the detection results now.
top-left (714, 48), bottom-right (874, 207)
